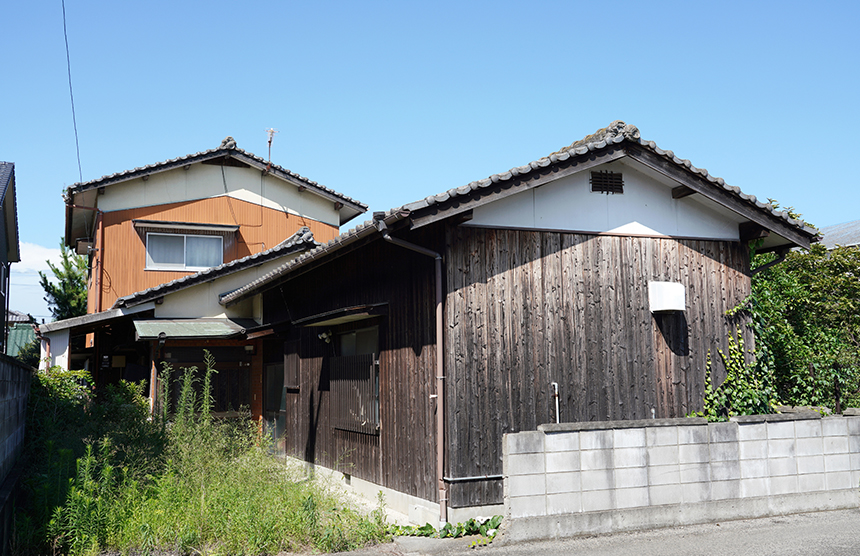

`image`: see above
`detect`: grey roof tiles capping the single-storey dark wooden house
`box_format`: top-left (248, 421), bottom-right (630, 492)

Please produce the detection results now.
top-left (221, 120), bottom-right (817, 305)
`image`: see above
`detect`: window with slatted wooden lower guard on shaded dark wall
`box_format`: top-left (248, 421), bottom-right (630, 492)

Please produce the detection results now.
top-left (329, 326), bottom-right (379, 434)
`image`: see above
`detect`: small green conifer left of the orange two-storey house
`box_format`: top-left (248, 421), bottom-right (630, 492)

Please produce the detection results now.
top-left (39, 240), bottom-right (87, 320)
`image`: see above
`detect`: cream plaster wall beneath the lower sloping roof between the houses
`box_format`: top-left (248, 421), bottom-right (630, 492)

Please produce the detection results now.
top-left (155, 255), bottom-right (297, 322)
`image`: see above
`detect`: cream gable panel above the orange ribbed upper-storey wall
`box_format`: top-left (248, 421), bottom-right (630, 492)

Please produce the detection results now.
top-left (98, 163), bottom-right (340, 226)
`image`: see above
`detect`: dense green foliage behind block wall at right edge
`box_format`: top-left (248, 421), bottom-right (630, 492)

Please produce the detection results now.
top-left (750, 244), bottom-right (860, 411)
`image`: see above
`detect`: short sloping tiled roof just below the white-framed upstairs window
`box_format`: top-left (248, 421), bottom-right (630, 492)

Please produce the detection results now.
top-left (112, 227), bottom-right (320, 309)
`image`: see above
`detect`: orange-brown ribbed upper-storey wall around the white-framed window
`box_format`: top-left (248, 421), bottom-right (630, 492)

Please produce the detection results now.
top-left (87, 196), bottom-right (338, 313)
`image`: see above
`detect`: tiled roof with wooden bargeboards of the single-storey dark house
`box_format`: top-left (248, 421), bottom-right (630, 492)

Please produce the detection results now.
top-left (220, 120), bottom-right (818, 305)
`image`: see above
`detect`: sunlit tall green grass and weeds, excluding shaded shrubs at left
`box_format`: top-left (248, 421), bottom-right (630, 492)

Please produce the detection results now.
top-left (17, 354), bottom-right (387, 555)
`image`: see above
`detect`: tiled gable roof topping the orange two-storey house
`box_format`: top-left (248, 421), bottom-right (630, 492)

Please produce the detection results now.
top-left (67, 137), bottom-right (367, 212)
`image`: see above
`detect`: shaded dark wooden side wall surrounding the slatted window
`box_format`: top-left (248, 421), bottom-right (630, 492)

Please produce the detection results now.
top-left (263, 232), bottom-right (436, 500)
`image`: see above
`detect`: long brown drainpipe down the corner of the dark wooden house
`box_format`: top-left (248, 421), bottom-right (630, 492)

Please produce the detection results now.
top-left (373, 213), bottom-right (448, 525)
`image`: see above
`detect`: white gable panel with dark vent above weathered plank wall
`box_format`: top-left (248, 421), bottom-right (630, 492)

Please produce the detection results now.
top-left (464, 161), bottom-right (743, 240)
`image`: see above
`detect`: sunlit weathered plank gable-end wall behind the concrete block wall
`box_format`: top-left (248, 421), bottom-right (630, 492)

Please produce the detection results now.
top-left (445, 227), bottom-right (749, 507)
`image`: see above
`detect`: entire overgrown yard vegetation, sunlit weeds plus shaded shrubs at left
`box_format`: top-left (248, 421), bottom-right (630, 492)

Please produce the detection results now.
top-left (15, 353), bottom-right (388, 554)
